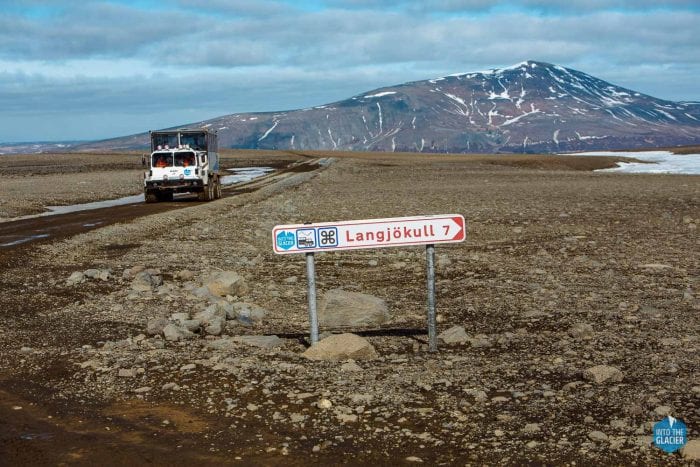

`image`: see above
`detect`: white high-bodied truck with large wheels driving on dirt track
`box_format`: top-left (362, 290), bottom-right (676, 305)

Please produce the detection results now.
top-left (143, 128), bottom-right (221, 203)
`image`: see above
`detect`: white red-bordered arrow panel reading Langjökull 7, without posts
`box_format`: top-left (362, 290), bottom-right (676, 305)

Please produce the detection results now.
top-left (272, 214), bottom-right (467, 255)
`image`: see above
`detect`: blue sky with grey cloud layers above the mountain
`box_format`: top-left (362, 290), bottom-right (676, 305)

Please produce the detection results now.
top-left (0, 0), bottom-right (700, 142)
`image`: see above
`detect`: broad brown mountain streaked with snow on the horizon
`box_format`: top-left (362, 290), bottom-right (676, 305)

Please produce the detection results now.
top-left (78, 61), bottom-right (700, 153)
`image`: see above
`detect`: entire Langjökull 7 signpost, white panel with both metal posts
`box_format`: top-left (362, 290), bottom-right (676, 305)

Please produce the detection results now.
top-left (272, 214), bottom-right (467, 352)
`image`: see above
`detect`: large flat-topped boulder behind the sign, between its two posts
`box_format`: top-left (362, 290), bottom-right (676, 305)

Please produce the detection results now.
top-left (318, 289), bottom-right (391, 329)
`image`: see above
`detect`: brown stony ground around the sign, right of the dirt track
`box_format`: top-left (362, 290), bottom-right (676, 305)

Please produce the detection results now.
top-left (0, 155), bottom-right (700, 465)
